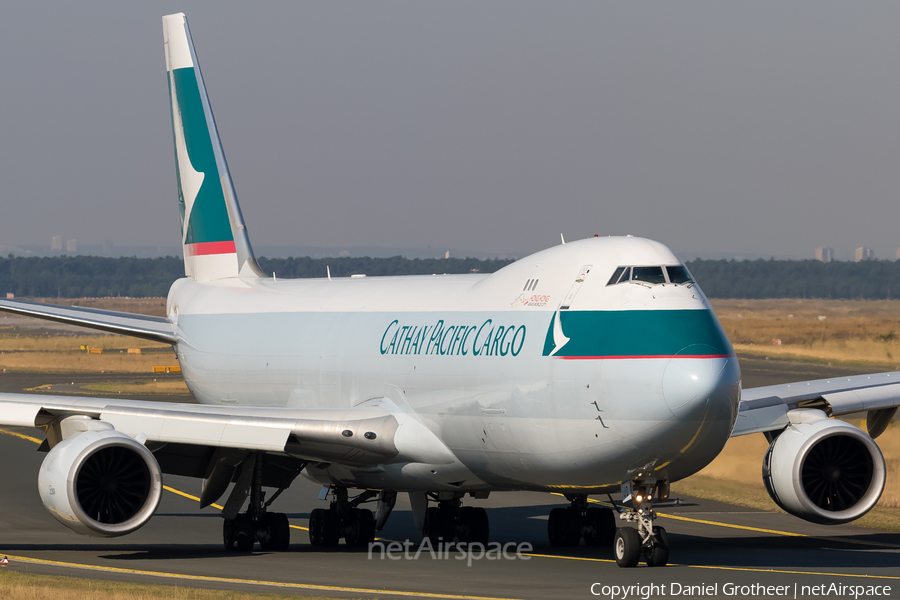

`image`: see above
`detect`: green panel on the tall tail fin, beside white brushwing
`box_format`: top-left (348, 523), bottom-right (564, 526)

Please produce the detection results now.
top-left (172, 67), bottom-right (234, 244)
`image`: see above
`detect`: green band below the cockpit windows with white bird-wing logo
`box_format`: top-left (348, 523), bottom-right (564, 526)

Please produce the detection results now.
top-left (544, 310), bottom-right (734, 358)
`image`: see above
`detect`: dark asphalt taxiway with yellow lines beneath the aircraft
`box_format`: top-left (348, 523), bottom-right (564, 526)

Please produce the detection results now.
top-left (0, 359), bottom-right (900, 599)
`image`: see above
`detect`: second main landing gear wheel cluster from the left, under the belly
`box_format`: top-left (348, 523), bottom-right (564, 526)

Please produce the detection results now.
top-left (309, 487), bottom-right (380, 547)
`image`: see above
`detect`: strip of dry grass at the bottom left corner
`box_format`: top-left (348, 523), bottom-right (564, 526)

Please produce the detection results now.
top-left (0, 569), bottom-right (338, 600)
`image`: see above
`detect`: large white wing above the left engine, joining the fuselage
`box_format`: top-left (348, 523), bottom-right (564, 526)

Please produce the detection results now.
top-left (0, 394), bottom-right (400, 466)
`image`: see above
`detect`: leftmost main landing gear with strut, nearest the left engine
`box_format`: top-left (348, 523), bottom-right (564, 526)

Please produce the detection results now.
top-left (222, 452), bottom-right (291, 552)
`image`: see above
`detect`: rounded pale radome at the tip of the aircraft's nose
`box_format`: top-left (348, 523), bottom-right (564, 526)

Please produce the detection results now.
top-left (662, 345), bottom-right (741, 423)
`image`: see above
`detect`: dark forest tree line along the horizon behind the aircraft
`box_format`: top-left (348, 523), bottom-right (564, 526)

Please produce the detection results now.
top-left (0, 255), bottom-right (900, 299)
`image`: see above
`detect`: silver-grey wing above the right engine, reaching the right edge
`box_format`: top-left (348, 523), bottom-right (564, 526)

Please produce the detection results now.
top-left (731, 372), bottom-right (900, 437)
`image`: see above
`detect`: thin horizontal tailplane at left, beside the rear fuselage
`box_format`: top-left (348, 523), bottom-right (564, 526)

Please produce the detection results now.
top-left (0, 298), bottom-right (177, 344)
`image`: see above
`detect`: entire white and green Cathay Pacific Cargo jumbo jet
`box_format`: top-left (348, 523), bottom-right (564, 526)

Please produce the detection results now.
top-left (0, 14), bottom-right (900, 567)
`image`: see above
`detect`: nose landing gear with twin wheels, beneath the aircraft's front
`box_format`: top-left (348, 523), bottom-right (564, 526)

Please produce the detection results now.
top-left (613, 479), bottom-right (669, 567)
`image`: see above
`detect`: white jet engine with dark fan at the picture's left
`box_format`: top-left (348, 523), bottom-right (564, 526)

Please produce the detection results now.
top-left (38, 429), bottom-right (162, 537)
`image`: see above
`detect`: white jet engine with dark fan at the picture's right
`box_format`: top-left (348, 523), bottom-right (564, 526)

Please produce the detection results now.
top-left (763, 410), bottom-right (885, 525)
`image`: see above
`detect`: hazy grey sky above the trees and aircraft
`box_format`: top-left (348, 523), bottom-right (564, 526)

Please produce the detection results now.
top-left (0, 0), bottom-right (900, 258)
